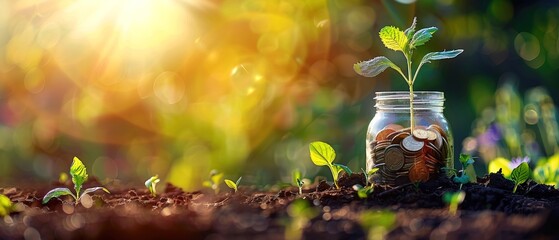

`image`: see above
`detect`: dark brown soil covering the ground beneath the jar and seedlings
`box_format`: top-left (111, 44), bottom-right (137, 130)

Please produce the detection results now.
top-left (0, 174), bottom-right (559, 240)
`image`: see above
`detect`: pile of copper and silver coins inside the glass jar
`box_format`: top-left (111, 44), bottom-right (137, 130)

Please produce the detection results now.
top-left (370, 124), bottom-right (449, 186)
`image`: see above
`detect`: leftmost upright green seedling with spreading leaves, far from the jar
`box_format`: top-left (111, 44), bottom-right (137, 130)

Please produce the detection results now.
top-left (43, 157), bottom-right (110, 205)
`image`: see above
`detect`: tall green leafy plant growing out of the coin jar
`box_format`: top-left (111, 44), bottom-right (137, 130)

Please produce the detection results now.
top-left (353, 18), bottom-right (464, 132)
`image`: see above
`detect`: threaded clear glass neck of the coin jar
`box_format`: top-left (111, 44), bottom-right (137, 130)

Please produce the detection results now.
top-left (375, 91), bottom-right (445, 113)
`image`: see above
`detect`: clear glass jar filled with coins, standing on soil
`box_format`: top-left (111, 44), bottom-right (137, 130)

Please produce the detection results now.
top-left (366, 91), bottom-right (454, 186)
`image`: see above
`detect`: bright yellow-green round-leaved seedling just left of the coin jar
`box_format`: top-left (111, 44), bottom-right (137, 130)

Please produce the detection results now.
top-left (309, 142), bottom-right (352, 189)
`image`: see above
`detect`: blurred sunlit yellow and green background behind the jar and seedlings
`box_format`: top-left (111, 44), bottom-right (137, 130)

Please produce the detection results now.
top-left (0, 0), bottom-right (559, 189)
